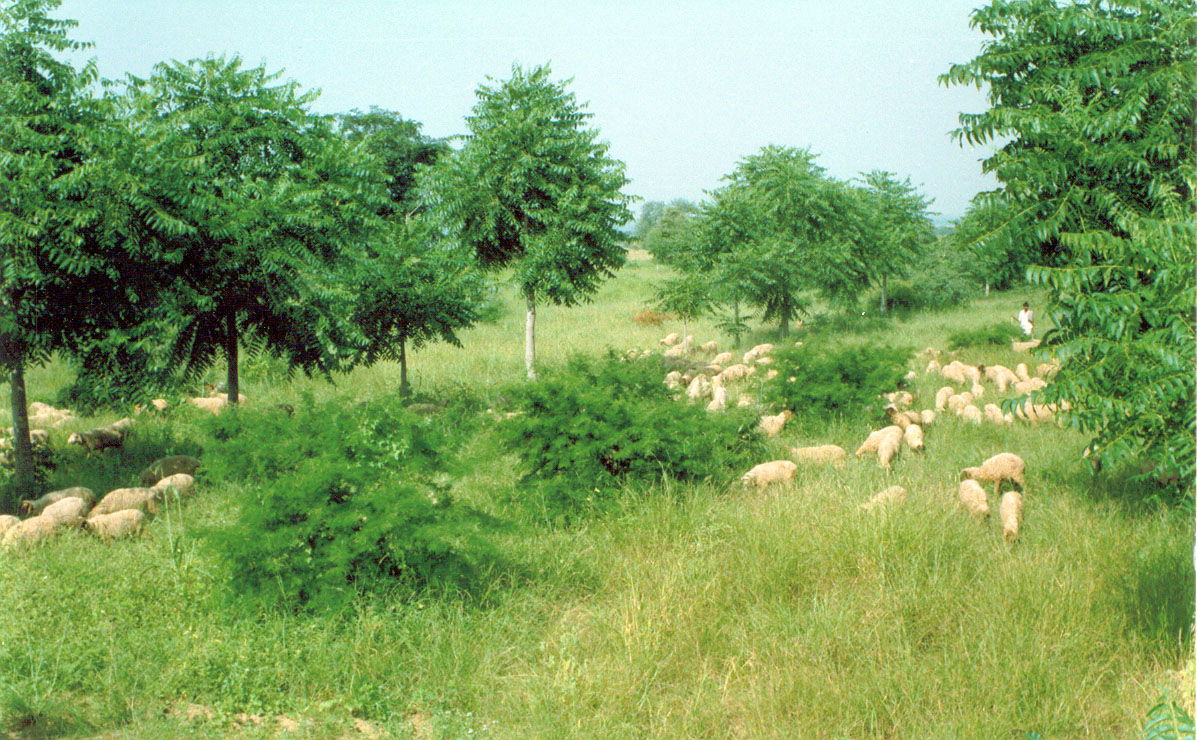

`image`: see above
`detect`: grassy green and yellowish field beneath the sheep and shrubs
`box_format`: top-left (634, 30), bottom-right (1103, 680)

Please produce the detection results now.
top-left (0, 255), bottom-right (1195, 740)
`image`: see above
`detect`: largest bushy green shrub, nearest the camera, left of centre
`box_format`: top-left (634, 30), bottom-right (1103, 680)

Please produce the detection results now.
top-left (205, 399), bottom-right (488, 609)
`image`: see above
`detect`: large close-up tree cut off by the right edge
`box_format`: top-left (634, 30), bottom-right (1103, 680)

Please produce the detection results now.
top-left (940, 0), bottom-right (1197, 492)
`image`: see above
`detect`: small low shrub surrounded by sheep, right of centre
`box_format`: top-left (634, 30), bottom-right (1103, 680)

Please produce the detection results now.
top-left (762, 341), bottom-right (910, 417)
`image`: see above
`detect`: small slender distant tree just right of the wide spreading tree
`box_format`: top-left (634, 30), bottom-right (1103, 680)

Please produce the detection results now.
top-left (857, 170), bottom-right (932, 315)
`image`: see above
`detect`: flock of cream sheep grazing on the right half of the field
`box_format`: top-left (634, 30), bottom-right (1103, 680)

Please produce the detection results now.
top-left (625, 334), bottom-right (1068, 542)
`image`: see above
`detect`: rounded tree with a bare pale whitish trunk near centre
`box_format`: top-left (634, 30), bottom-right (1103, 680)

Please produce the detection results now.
top-left (427, 66), bottom-right (632, 378)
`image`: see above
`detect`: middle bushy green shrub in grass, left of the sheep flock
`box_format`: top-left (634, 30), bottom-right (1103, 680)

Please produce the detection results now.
top-left (502, 354), bottom-right (761, 517)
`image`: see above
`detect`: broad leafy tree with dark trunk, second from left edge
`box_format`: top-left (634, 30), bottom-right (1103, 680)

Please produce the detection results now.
top-left (127, 57), bottom-right (385, 402)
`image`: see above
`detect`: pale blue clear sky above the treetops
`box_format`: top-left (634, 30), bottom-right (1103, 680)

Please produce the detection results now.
top-left (54, 0), bottom-right (996, 220)
